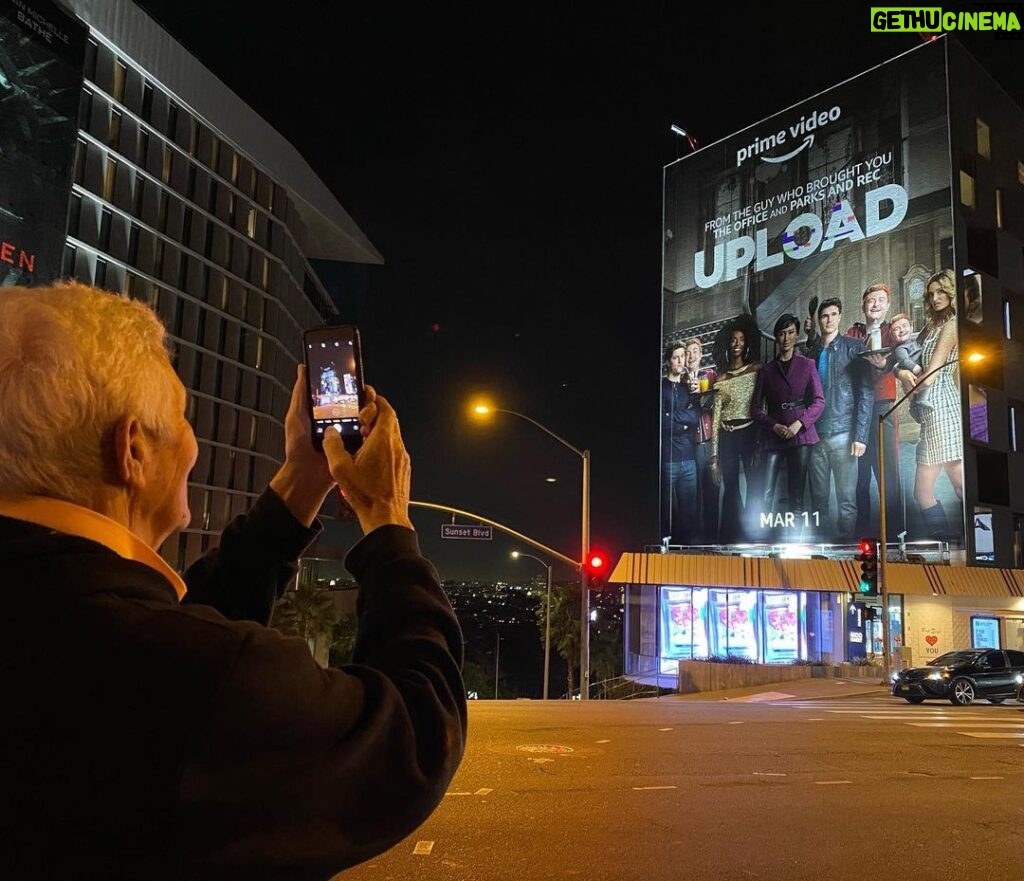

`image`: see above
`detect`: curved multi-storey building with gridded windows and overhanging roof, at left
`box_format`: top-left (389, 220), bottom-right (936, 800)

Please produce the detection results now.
top-left (0, 0), bottom-right (383, 569)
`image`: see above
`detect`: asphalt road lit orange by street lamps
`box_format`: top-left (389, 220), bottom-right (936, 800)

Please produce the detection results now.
top-left (337, 695), bottom-right (1024, 881)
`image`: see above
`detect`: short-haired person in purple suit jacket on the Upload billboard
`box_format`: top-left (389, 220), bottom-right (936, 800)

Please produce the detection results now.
top-left (751, 313), bottom-right (825, 527)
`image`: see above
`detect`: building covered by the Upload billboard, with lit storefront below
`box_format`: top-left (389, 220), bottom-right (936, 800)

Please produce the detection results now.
top-left (611, 38), bottom-right (1024, 674)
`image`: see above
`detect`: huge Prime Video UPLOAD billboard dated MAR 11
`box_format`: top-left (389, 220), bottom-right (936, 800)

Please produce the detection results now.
top-left (658, 44), bottom-right (964, 546)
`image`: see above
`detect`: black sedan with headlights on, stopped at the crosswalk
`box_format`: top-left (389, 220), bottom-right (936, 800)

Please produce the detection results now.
top-left (893, 648), bottom-right (1024, 707)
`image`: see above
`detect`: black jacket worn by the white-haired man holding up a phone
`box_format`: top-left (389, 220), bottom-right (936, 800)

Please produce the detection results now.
top-left (0, 492), bottom-right (466, 881)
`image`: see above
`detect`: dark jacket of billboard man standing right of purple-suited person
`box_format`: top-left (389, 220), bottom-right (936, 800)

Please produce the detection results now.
top-left (807, 334), bottom-right (874, 444)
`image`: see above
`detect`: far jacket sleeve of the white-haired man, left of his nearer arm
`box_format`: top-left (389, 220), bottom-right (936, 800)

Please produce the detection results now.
top-left (182, 490), bottom-right (323, 625)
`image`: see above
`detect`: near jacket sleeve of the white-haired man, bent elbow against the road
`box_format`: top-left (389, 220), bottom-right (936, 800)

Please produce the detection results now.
top-left (179, 527), bottom-right (466, 881)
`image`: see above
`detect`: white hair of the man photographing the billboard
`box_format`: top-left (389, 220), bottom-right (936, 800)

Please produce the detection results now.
top-left (0, 282), bottom-right (181, 505)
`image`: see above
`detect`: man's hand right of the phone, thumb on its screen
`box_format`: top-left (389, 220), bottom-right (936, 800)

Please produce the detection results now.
top-left (324, 385), bottom-right (413, 535)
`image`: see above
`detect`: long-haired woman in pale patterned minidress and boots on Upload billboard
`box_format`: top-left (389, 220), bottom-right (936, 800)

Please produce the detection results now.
top-left (905, 269), bottom-right (964, 539)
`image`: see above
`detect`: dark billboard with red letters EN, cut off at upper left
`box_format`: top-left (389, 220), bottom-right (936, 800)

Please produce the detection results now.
top-left (0, 0), bottom-right (88, 286)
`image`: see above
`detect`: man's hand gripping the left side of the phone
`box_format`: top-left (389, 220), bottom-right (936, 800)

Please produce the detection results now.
top-left (270, 364), bottom-right (334, 527)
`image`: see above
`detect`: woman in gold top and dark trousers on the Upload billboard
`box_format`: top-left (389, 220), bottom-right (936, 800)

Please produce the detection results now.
top-left (711, 316), bottom-right (762, 544)
